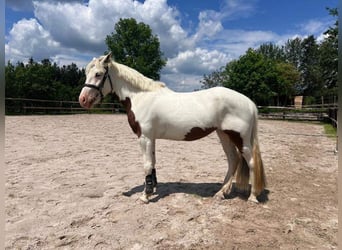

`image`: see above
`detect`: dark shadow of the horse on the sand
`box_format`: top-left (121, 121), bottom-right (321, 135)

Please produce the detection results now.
top-left (123, 182), bottom-right (269, 202)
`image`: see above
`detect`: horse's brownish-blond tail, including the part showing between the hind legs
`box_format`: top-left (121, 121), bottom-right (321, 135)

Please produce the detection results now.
top-left (235, 105), bottom-right (266, 195)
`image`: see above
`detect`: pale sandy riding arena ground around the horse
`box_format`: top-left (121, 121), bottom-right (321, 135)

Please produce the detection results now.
top-left (5, 115), bottom-right (338, 250)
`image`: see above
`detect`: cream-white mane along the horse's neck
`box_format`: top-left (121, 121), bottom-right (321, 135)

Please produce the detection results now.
top-left (111, 61), bottom-right (166, 91)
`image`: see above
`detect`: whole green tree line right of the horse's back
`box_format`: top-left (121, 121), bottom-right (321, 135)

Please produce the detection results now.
top-left (201, 8), bottom-right (338, 106)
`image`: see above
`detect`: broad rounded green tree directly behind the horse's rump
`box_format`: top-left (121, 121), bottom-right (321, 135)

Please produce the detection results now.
top-left (201, 49), bottom-right (299, 105)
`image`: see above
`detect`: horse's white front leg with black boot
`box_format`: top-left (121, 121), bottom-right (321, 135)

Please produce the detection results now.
top-left (139, 135), bottom-right (157, 203)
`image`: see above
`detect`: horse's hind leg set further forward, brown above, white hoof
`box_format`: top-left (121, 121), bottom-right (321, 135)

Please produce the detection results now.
top-left (215, 130), bottom-right (241, 199)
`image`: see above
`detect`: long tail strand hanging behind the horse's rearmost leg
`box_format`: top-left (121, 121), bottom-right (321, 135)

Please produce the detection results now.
top-left (251, 108), bottom-right (266, 196)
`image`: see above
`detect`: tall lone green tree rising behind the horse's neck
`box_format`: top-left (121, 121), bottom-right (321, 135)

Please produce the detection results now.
top-left (106, 18), bottom-right (166, 80)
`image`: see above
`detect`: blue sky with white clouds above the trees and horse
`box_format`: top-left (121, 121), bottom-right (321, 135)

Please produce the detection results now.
top-left (5, 0), bottom-right (338, 91)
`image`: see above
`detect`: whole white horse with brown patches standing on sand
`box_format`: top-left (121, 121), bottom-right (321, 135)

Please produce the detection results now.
top-left (79, 53), bottom-right (266, 203)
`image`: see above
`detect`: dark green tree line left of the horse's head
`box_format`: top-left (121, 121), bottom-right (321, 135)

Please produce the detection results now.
top-left (5, 58), bottom-right (85, 101)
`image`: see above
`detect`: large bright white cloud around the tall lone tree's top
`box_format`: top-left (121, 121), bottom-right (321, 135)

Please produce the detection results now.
top-left (34, 0), bottom-right (188, 56)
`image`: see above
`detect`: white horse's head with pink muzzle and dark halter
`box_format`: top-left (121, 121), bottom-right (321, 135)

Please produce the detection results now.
top-left (79, 53), bottom-right (113, 109)
